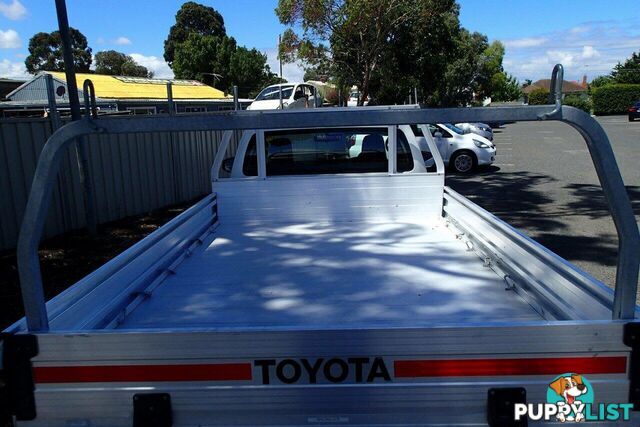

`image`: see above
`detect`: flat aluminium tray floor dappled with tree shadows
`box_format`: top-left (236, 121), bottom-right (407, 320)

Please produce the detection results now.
top-left (120, 223), bottom-right (542, 329)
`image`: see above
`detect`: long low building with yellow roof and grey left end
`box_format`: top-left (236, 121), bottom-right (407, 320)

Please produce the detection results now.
top-left (0, 71), bottom-right (251, 117)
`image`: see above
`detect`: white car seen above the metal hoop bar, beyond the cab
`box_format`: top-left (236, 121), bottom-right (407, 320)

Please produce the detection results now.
top-left (247, 83), bottom-right (322, 110)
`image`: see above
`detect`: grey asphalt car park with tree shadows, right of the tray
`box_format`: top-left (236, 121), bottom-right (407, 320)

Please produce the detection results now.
top-left (447, 116), bottom-right (640, 300)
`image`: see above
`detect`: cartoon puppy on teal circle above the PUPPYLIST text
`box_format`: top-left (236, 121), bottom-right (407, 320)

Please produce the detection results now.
top-left (547, 373), bottom-right (593, 422)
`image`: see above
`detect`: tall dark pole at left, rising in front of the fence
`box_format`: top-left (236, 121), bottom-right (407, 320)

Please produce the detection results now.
top-left (55, 0), bottom-right (97, 234)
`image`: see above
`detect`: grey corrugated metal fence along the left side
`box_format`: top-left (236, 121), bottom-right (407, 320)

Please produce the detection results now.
top-left (0, 118), bottom-right (235, 250)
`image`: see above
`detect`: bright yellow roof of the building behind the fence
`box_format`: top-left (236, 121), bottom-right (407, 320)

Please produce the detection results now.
top-left (48, 72), bottom-right (231, 100)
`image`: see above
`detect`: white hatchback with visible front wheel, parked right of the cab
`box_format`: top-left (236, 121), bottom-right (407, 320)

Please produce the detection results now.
top-left (413, 124), bottom-right (496, 173)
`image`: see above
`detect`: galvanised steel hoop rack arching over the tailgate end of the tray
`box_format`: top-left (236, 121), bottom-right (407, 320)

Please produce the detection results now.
top-left (18, 64), bottom-right (640, 332)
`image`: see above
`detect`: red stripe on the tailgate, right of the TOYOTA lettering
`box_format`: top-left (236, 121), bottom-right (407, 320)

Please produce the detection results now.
top-left (393, 356), bottom-right (627, 378)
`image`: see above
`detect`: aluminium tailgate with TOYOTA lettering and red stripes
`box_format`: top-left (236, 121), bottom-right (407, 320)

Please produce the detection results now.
top-left (7, 322), bottom-right (631, 426)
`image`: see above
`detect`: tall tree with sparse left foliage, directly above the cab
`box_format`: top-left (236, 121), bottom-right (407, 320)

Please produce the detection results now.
top-left (276, 0), bottom-right (417, 105)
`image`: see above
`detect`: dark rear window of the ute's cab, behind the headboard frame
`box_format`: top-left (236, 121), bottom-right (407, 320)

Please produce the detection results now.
top-left (243, 128), bottom-right (413, 176)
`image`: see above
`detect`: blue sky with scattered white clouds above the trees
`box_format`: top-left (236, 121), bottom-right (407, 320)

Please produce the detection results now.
top-left (0, 0), bottom-right (640, 80)
